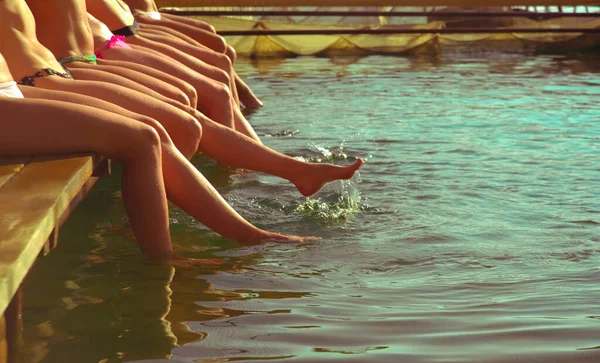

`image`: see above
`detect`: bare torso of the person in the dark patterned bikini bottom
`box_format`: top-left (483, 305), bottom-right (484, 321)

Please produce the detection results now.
top-left (0, 0), bottom-right (63, 80)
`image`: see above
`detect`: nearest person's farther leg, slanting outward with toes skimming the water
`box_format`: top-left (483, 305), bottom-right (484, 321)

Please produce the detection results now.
top-left (14, 87), bottom-right (314, 243)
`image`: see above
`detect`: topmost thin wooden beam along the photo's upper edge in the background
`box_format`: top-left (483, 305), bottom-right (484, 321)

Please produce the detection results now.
top-left (156, 0), bottom-right (600, 8)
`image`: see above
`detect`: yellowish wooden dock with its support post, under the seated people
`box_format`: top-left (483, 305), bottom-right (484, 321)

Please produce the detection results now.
top-left (0, 155), bottom-right (110, 363)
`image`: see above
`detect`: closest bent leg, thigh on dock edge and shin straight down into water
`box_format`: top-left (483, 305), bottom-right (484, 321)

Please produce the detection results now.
top-left (0, 97), bottom-right (172, 256)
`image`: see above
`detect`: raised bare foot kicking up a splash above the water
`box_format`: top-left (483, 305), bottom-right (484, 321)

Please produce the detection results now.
top-left (291, 158), bottom-right (365, 197)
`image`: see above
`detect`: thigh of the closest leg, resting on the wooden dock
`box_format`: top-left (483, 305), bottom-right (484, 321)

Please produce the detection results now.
top-left (0, 97), bottom-right (152, 160)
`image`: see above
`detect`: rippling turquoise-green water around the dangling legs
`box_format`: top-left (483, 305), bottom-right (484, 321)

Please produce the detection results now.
top-left (22, 54), bottom-right (600, 363)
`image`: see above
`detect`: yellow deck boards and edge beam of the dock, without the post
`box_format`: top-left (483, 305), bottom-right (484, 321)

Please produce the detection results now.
top-left (0, 156), bottom-right (93, 312)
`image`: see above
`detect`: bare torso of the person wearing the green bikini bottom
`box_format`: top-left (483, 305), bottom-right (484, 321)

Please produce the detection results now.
top-left (27, 0), bottom-right (94, 59)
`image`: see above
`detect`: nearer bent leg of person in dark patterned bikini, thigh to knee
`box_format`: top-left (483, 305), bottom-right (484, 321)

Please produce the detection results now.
top-left (36, 76), bottom-right (202, 158)
